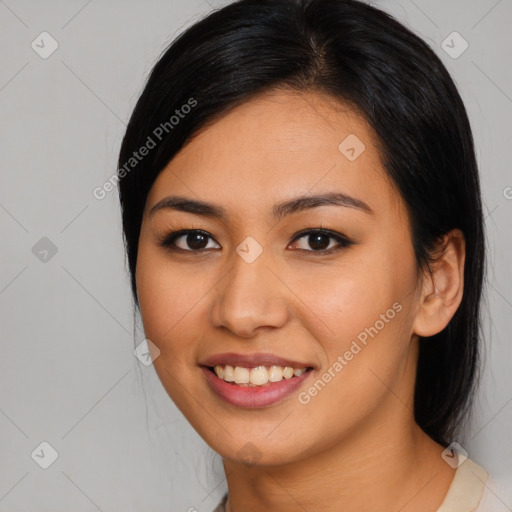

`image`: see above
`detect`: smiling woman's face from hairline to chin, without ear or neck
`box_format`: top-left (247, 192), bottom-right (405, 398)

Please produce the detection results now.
top-left (136, 90), bottom-right (420, 465)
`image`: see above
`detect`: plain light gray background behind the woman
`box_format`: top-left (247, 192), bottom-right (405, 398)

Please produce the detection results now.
top-left (0, 0), bottom-right (512, 512)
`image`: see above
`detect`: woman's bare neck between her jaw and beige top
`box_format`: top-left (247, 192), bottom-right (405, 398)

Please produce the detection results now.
top-left (224, 399), bottom-right (455, 512)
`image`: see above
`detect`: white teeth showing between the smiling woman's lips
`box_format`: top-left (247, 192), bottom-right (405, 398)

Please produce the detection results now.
top-left (207, 365), bottom-right (313, 387)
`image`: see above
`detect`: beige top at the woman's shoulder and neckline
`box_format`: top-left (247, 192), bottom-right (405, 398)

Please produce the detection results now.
top-left (213, 459), bottom-right (488, 512)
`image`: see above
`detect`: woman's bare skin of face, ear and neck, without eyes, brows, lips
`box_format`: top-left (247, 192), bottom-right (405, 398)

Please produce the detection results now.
top-left (136, 89), bottom-right (465, 512)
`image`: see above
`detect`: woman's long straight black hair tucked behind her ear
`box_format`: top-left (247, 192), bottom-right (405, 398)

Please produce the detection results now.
top-left (118, 0), bottom-right (485, 445)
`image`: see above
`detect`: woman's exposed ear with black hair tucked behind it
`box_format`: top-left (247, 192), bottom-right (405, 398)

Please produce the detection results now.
top-left (413, 229), bottom-right (466, 337)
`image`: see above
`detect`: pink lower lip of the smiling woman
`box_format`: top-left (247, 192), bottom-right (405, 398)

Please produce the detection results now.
top-left (201, 366), bottom-right (313, 408)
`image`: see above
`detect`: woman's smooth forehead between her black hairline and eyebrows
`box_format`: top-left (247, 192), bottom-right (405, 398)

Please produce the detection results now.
top-left (147, 90), bottom-right (399, 222)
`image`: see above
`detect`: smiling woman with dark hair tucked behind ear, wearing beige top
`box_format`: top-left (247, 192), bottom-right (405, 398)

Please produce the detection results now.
top-left (119, 0), bottom-right (487, 512)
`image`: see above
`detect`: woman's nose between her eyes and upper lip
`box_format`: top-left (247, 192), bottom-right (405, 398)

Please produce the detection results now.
top-left (210, 245), bottom-right (289, 338)
